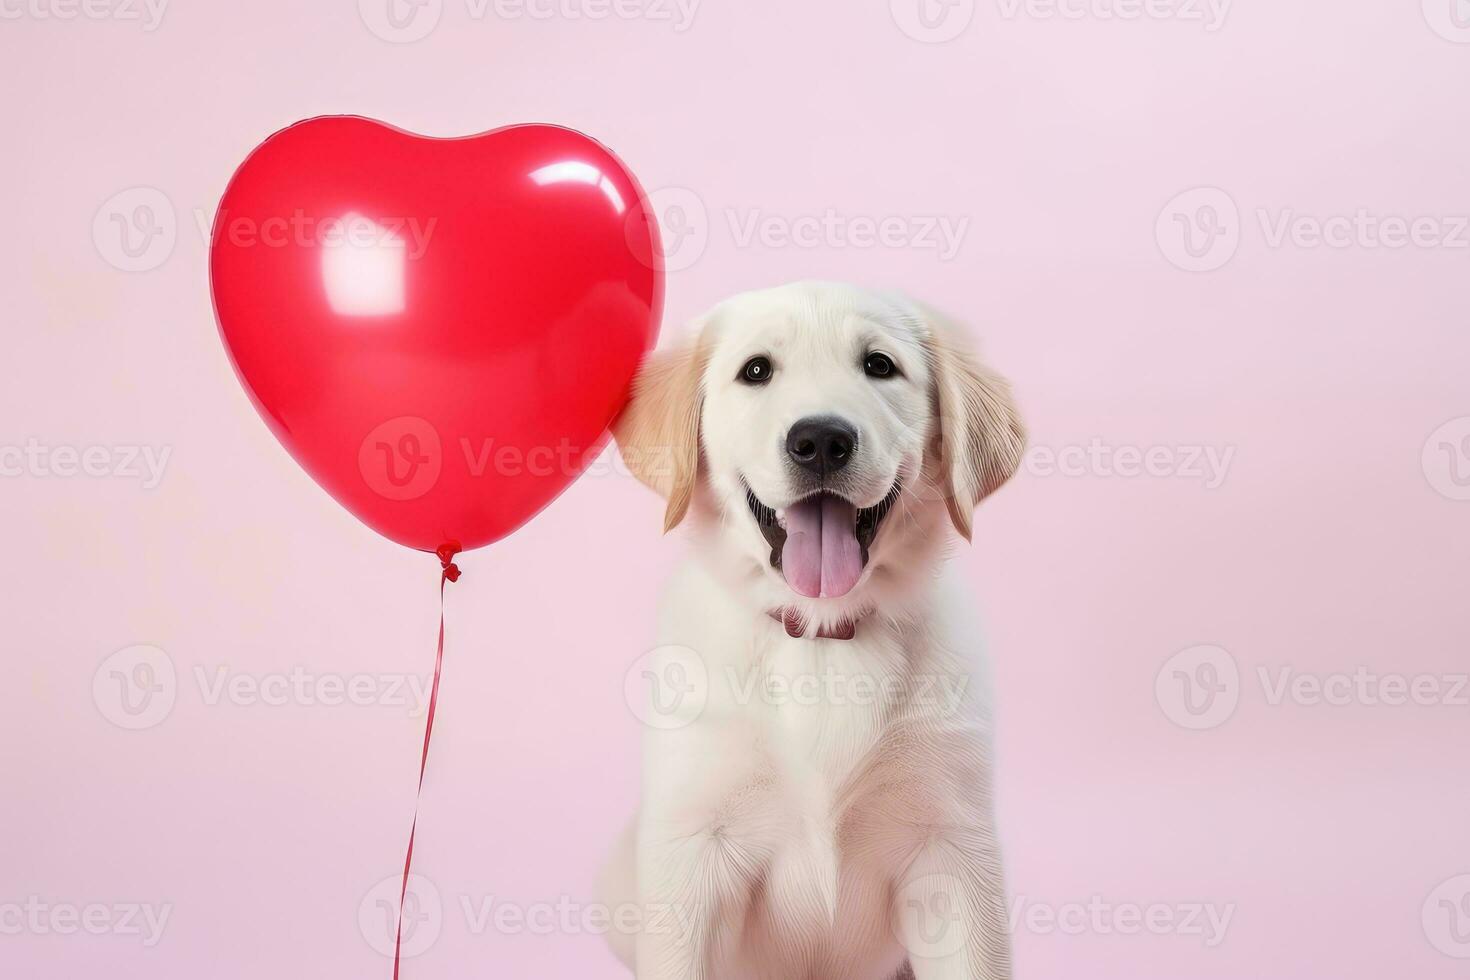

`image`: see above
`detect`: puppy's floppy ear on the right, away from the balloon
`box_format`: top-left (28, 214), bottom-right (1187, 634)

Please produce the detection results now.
top-left (923, 310), bottom-right (1026, 541)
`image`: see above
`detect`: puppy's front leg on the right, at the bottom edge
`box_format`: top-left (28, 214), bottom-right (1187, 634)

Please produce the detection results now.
top-left (892, 830), bottom-right (1011, 980)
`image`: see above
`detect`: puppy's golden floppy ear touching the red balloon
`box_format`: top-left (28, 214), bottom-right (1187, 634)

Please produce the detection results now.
top-left (613, 332), bottom-right (707, 532)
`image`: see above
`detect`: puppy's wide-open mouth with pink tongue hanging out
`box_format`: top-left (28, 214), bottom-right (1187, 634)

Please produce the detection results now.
top-left (745, 483), bottom-right (901, 598)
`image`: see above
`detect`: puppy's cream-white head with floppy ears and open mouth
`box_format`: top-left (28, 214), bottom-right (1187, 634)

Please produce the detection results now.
top-left (613, 284), bottom-right (1025, 601)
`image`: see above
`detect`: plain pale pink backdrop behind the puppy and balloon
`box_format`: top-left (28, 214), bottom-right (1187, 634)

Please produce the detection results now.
top-left (0, 0), bottom-right (1470, 980)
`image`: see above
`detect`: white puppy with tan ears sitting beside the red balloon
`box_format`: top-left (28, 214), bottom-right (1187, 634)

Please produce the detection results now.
top-left (604, 284), bottom-right (1025, 980)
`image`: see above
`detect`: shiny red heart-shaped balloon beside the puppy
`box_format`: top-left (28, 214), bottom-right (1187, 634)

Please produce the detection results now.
top-left (210, 116), bottom-right (663, 551)
